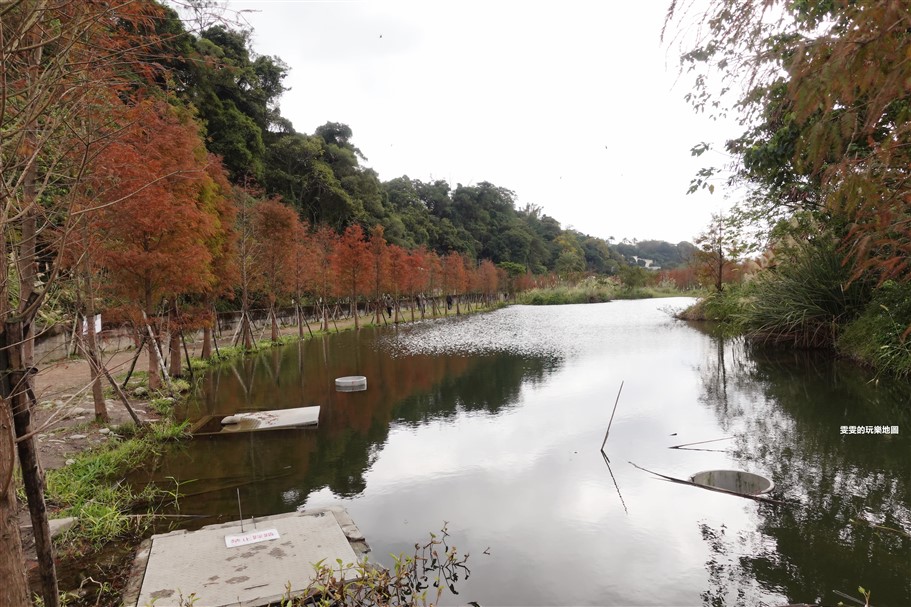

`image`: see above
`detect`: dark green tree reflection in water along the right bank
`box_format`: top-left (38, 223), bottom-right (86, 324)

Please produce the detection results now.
top-left (700, 337), bottom-right (911, 606)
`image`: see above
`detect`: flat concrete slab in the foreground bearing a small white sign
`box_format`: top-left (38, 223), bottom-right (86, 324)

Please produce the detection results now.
top-left (123, 507), bottom-right (369, 607)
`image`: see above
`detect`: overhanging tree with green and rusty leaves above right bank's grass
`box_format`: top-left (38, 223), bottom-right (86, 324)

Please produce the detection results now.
top-left (669, 0), bottom-right (911, 281)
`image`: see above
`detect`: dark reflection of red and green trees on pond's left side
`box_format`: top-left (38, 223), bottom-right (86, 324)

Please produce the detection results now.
top-left (142, 329), bottom-right (559, 526)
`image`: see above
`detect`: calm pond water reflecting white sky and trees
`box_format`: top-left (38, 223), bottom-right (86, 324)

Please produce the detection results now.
top-left (137, 299), bottom-right (911, 607)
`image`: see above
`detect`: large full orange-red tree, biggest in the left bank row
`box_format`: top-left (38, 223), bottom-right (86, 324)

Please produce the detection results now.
top-left (93, 101), bottom-right (219, 388)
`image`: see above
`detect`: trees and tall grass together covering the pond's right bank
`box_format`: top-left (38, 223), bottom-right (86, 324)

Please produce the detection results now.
top-left (667, 0), bottom-right (911, 377)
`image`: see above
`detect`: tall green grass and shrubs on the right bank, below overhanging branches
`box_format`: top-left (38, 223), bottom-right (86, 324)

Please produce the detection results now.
top-left (678, 243), bottom-right (911, 378)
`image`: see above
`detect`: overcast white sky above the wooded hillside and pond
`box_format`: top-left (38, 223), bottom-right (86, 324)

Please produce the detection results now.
top-left (229, 0), bottom-right (736, 243)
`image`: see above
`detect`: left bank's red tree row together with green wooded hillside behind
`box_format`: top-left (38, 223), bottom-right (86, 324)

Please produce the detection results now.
top-left (0, 0), bottom-right (700, 607)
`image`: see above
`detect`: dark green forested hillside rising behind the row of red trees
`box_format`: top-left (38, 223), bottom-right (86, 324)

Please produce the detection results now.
top-left (157, 15), bottom-right (687, 274)
